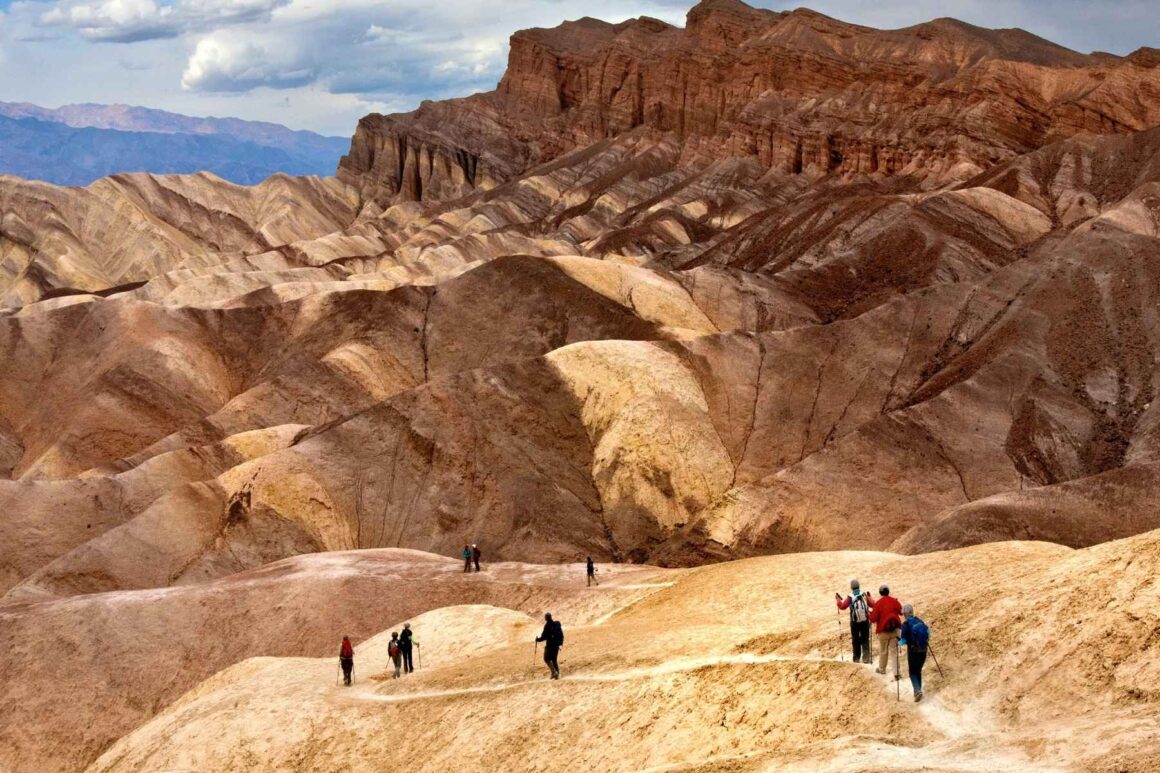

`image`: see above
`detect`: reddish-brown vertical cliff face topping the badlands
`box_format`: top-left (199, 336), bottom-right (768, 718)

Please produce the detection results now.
top-left (340, 0), bottom-right (1160, 204)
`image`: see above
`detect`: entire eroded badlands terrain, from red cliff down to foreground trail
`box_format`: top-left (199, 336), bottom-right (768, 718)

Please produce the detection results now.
top-left (0, 0), bottom-right (1160, 772)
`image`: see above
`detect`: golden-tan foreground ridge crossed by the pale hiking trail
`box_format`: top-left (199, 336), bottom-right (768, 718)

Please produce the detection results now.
top-left (90, 532), bottom-right (1160, 771)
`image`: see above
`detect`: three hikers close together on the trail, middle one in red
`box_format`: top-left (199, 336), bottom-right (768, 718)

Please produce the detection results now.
top-left (834, 579), bottom-right (930, 703)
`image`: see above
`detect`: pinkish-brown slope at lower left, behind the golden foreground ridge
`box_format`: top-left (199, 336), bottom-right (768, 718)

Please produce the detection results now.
top-left (0, 550), bottom-right (664, 771)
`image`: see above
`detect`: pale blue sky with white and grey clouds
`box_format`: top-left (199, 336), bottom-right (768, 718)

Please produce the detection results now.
top-left (0, 0), bottom-right (1160, 136)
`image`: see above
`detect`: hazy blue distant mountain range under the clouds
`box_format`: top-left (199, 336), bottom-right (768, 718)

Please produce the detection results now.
top-left (0, 102), bottom-right (350, 186)
